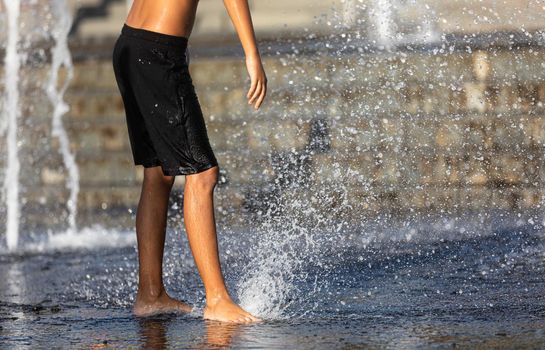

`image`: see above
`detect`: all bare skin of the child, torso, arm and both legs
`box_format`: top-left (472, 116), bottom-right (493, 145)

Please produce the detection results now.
top-left (126, 0), bottom-right (267, 323)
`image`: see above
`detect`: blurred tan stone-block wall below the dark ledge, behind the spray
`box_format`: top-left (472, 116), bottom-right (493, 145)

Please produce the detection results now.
top-left (3, 32), bottom-right (545, 230)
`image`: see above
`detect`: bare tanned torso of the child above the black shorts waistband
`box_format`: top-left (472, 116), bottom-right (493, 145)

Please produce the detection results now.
top-left (126, 0), bottom-right (199, 38)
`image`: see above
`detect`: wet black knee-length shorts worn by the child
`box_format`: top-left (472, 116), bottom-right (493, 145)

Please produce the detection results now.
top-left (113, 25), bottom-right (218, 176)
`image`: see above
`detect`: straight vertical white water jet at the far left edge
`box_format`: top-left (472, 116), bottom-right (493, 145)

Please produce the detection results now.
top-left (0, 0), bottom-right (21, 249)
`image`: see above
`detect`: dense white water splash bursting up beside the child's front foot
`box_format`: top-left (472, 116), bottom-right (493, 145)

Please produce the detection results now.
top-left (237, 149), bottom-right (349, 319)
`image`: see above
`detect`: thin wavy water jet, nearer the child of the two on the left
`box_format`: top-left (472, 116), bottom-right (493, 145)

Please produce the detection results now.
top-left (46, 0), bottom-right (80, 233)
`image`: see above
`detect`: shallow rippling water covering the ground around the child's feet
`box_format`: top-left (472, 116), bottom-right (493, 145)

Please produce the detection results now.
top-left (0, 214), bottom-right (545, 349)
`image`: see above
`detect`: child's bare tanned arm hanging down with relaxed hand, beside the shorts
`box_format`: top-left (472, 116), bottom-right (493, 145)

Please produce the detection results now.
top-left (223, 0), bottom-right (267, 109)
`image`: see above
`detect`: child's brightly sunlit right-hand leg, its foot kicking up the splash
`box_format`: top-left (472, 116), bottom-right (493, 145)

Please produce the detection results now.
top-left (184, 166), bottom-right (257, 323)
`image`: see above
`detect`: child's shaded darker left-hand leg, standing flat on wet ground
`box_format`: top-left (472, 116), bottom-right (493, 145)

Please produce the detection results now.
top-left (134, 167), bottom-right (191, 316)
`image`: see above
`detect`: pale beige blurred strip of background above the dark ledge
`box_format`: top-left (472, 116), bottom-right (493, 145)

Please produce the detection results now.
top-left (69, 0), bottom-right (545, 40)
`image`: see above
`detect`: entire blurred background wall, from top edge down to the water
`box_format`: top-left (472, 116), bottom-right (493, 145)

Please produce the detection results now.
top-left (0, 0), bottom-right (545, 232)
